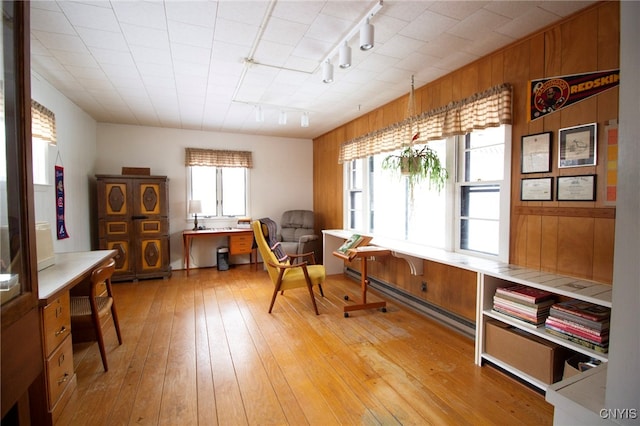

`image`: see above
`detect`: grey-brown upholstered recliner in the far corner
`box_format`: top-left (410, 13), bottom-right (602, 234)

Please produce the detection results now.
top-left (280, 210), bottom-right (322, 264)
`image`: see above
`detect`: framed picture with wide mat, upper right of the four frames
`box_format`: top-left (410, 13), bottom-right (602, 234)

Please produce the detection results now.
top-left (558, 123), bottom-right (598, 168)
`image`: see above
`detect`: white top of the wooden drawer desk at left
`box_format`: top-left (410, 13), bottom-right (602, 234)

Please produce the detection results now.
top-left (38, 250), bottom-right (117, 306)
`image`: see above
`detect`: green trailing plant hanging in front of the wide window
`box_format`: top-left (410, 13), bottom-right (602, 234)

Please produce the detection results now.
top-left (382, 137), bottom-right (449, 194)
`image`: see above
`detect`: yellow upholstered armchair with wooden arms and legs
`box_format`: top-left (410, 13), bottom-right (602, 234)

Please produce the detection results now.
top-left (251, 220), bottom-right (326, 315)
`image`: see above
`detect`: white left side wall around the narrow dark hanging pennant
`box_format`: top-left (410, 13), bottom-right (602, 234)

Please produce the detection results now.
top-left (31, 72), bottom-right (96, 253)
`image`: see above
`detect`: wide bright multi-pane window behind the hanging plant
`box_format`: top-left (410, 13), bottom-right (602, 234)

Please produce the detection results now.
top-left (344, 126), bottom-right (511, 260)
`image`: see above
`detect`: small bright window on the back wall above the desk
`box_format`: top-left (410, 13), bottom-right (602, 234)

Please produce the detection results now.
top-left (188, 166), bottom-right (248, 217)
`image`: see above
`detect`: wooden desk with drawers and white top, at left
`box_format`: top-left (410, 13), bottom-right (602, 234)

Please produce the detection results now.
top-left (29, 250), bottom-right (117, 425)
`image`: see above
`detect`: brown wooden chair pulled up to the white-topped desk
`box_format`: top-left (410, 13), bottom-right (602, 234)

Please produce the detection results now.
top-left (70, 259), bottom-right (122, 371)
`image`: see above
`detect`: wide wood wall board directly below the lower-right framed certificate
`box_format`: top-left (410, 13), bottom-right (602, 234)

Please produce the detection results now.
top-left (557, 217), bottom-right (595, 279)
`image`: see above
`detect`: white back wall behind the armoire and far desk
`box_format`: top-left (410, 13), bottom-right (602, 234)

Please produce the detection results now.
top-left (95, 123), bottom-right (313, 269)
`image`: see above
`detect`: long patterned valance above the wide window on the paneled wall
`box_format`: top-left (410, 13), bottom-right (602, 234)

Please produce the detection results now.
top-left (338, 84), bottom-right (511, 163)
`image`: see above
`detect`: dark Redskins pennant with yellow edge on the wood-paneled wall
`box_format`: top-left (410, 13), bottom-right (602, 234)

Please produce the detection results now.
top-left (527, 69), bottom-right (620, 121)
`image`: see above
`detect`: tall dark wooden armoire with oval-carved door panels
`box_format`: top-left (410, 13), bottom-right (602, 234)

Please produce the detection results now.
top-left (96, 175), bottom-right (171, 281)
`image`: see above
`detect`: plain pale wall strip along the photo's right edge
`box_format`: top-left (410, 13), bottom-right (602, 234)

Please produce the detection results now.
top-left (606, 1), bottom-right (640, 425)
